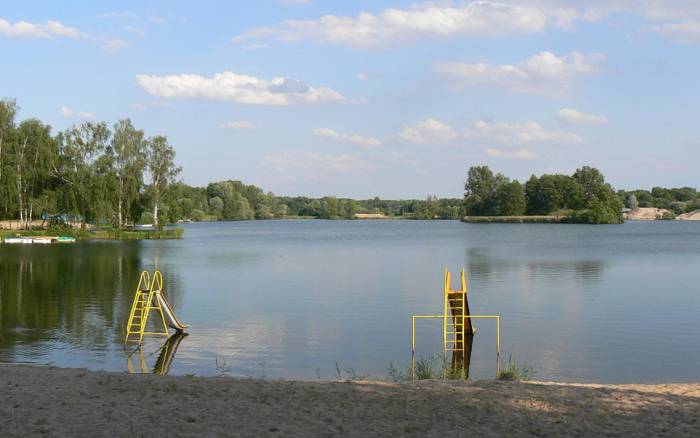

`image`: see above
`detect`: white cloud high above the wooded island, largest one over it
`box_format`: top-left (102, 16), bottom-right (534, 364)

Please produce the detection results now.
top-left (434, 52), bottom-right (604, 94)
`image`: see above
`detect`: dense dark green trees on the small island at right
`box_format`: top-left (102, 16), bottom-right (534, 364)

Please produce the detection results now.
top-left (464, 166), bottom-right (623, 223)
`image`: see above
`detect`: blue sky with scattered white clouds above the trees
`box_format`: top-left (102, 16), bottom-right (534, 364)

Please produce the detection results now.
top-left (0, 0), bottom-right (700, 198)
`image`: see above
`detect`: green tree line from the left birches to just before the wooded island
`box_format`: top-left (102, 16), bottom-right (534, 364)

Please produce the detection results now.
top-left (0, 99), bottom-right (465, 229)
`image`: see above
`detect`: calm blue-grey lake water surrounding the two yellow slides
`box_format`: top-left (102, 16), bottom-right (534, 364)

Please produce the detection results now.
top-left (0, 221), bottom-right (700, 383)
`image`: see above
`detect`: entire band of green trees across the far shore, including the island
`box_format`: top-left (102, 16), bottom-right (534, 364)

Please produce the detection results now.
top-left (0, 99), bottom-right (700, 231)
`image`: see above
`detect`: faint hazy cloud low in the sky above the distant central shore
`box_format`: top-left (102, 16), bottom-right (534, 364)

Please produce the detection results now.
top-left (260, 151), bottom-right (369, 181)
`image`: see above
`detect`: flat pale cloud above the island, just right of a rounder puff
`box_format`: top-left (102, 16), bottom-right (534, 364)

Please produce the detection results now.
top-left (464, 120), bottom-right (583, 145)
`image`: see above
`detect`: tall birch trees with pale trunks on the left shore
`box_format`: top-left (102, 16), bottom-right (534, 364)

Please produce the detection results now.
top-left (0, 99), bottom-right (180, 228)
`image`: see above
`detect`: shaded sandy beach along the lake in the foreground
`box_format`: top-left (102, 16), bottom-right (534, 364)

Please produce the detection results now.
top-left (0, 364), bottom-right (700, 437)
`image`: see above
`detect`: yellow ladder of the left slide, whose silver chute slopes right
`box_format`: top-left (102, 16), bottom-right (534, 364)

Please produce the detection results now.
top-left (124, 271), bottom-right (169, 345)
